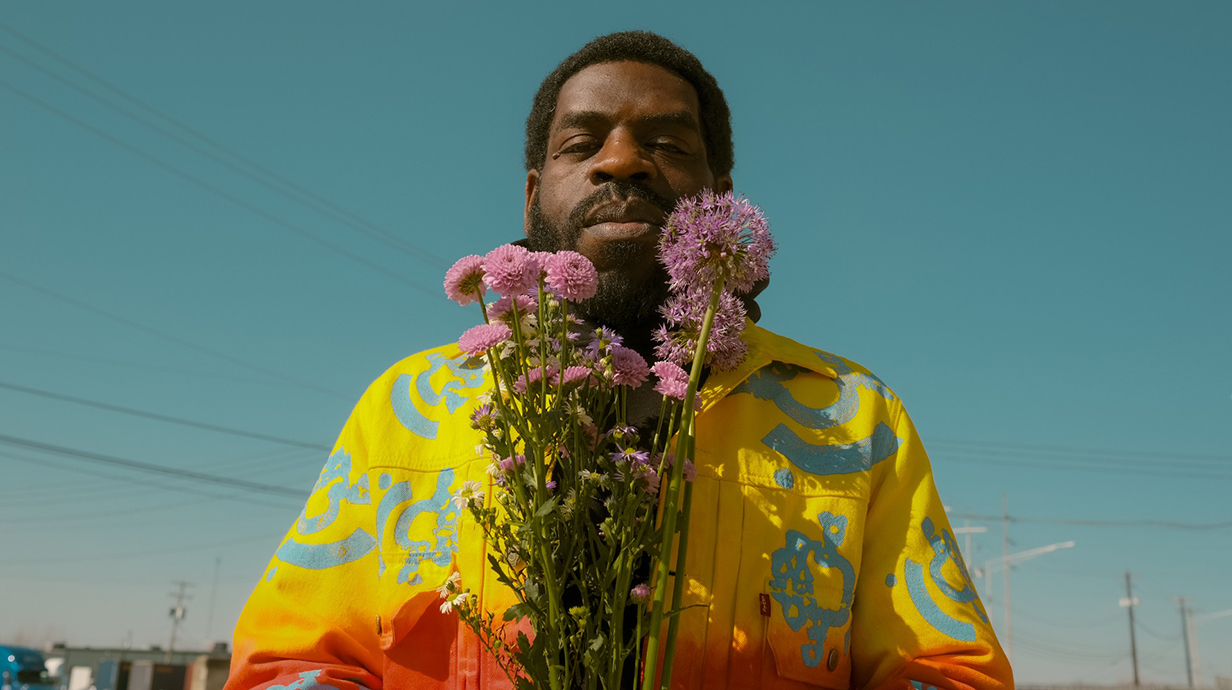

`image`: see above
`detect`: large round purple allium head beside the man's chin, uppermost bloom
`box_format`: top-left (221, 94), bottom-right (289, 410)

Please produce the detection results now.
top-left (659, 190), bottom-right (775, 293)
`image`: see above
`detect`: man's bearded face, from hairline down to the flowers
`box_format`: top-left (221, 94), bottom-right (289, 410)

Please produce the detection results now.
top-left (525, 62), bottom-right (732, 333)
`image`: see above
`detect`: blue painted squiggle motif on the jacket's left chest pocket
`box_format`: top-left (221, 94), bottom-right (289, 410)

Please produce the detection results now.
top-left (377, 467), bottom-right (458, 584)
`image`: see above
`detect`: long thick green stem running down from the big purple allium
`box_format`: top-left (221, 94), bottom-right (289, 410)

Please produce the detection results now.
top-left (642, 280), bottom-right (723, 690)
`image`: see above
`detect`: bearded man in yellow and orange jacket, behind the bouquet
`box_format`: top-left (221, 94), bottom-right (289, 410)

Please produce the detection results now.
top-left (228, 32), bottom-right (1013, 690)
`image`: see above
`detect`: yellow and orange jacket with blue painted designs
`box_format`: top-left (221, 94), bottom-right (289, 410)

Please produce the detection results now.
top-left (227, 325), bottom-right (1013, 690)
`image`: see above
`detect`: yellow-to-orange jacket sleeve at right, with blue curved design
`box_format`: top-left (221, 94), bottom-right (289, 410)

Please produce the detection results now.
top-left (851, 399), bottom-right (1014, 690)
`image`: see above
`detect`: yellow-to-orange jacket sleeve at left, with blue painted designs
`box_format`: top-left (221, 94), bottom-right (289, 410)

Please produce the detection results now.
top-left (225, 403), bottom-right (382, 690)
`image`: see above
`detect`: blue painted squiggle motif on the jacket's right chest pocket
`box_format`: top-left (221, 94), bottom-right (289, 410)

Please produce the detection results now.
top-left (770, 513), bottom-right (855, 668)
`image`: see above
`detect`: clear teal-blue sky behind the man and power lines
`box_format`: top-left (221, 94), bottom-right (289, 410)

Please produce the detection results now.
top-left (0, 1), bottom-right (1232, 683)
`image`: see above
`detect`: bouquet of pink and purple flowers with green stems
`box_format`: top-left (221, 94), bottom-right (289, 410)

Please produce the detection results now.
top-left (439, 191), bottom-right (774, 690)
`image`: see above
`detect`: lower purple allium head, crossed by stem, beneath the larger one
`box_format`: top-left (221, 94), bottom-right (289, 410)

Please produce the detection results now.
top-left (654, 291), bottom-right (748, 371)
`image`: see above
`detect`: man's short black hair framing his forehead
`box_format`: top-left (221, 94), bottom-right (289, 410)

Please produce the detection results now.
top-left (525, 31), bottom-right (736, 177)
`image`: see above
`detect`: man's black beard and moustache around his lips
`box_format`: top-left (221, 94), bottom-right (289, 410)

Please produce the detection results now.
top-left (526, 181), bottom-right (671, 352)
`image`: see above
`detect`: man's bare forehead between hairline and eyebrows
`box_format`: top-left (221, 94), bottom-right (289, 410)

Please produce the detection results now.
top-left (552, 62), bottom-right (700, 131)
